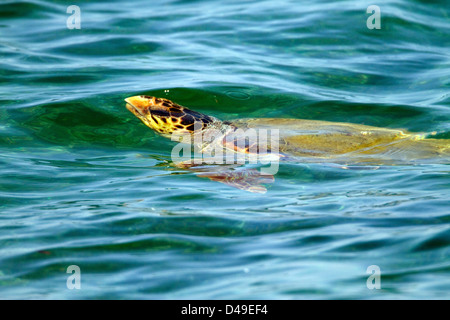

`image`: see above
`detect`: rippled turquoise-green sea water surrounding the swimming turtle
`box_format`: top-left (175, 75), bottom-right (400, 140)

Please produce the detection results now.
top-left (0, 0), bottom-right (450, 299)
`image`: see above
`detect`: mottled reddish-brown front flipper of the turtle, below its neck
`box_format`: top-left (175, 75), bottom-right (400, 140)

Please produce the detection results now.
top-left (176, 160), bottom-right (275, 193)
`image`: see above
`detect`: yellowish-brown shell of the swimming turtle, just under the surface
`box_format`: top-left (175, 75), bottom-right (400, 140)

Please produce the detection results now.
top-left (231, 118), bottom-right (450, 165)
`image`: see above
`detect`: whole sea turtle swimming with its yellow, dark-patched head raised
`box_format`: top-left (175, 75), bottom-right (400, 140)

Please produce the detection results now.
top-left (125, 96), bottom-right (450, 192)
